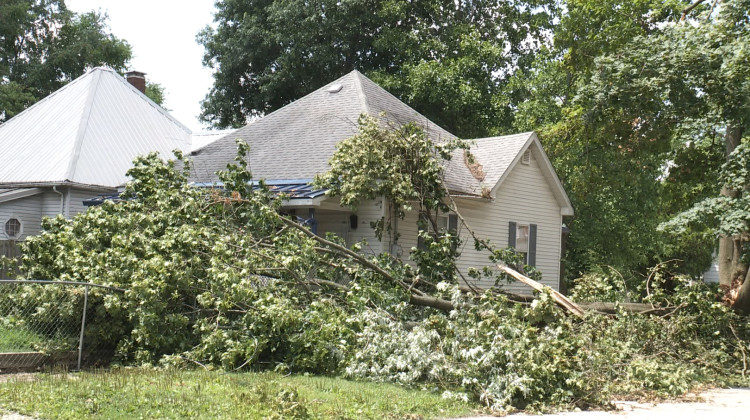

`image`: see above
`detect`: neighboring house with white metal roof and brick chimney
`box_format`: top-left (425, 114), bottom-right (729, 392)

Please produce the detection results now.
top-left (0, 68), bottom-right (210, 275)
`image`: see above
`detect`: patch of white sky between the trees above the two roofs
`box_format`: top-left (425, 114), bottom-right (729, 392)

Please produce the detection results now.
top-left (65, 0), bottom-right (219, 131)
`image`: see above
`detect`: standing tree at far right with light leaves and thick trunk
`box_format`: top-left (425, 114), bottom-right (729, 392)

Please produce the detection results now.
top-left (560, 0), bottom-right (750, 308)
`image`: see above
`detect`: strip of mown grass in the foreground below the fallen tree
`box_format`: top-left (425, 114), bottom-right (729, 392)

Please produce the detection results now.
top-left (0, 369), bottom-right (477, 419)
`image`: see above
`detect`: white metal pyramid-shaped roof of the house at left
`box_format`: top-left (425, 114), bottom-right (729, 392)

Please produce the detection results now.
top-left (0, 67), bottom-right (191, 187)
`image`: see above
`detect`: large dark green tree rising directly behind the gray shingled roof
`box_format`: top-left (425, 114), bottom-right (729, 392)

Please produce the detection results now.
top-left (198, 0), bottom-right (556, 137)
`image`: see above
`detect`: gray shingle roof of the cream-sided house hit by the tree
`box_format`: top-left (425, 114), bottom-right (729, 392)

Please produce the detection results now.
top-left (191, 71), bottom-right (568, 208)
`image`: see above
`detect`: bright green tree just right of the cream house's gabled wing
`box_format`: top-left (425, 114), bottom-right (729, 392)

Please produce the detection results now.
top-left (509, 0), bottom-right (721, 277)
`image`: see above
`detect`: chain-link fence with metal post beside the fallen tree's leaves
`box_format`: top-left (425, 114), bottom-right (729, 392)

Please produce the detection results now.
top-left (0, 280), bottom-right (124, 371)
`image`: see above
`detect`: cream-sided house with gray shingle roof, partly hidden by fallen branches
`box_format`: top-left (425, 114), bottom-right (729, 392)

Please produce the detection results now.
top-left (191, 71), bottom-right (573, 291)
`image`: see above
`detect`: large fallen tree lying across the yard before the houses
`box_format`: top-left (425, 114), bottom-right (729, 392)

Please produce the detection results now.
top-left (8, 120), bottom-right (750, 411)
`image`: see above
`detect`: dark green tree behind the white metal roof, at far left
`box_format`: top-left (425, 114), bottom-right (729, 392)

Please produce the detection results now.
top-left (0, 0), bottom-right (131, 121)
